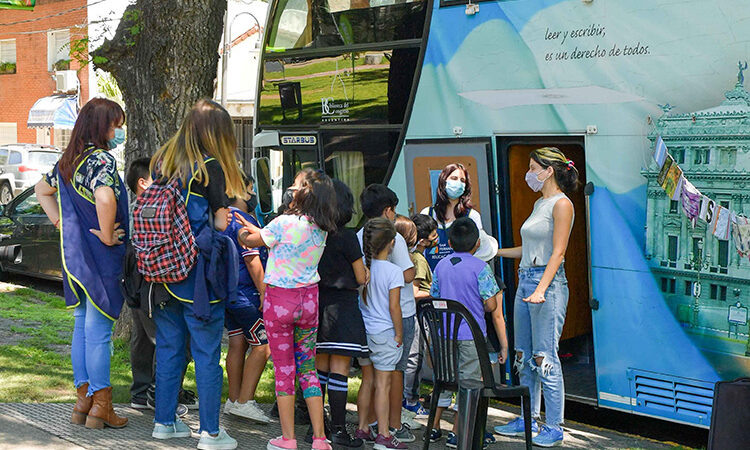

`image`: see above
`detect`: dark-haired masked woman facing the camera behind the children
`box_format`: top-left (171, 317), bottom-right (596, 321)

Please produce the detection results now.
top-left (421, 163), bottom-right (490, 270)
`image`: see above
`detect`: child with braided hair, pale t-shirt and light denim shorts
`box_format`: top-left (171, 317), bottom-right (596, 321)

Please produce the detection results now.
top-left (359, 218), bottom-right (407, 450)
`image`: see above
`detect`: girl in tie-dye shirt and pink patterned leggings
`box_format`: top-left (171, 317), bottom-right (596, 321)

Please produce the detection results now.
top-left (238, 169), bottom-right (337, 450)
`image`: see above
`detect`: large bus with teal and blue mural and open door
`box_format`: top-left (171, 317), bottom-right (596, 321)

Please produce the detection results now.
top-left (255, 0), bottom-right (750, 427)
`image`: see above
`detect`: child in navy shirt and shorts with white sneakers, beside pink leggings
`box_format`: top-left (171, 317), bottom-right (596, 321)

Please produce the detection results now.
top-left (222, 199), bottom-right (271, 424)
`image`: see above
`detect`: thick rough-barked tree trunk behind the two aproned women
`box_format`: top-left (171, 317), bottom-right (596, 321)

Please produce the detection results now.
top-left (92, 0), bottom-right (227, 338)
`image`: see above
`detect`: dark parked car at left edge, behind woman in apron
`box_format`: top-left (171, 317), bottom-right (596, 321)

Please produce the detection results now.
top-left (0, 186), bottom-right (62, 280)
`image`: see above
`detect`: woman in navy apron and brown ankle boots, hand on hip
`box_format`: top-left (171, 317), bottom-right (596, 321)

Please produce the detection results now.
top-left (35, 98), bottom-right (128, 428)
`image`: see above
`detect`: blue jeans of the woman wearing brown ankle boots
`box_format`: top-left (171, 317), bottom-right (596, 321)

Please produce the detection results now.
top-left (70, 299), bottom-right (114, 397)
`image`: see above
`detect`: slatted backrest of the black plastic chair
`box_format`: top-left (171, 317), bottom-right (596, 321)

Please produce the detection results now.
top-left (417, 298), bottom-right (495, 389)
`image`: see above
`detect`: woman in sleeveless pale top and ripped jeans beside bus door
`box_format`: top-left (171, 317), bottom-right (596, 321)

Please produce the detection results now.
top-left (495, 147), bottom-right (578, 447)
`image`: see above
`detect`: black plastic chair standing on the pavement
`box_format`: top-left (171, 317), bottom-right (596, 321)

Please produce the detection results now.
top-left (417, 299), bottom-right (531, 450)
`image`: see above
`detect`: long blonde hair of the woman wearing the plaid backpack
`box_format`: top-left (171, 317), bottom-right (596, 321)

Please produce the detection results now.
top-left (151, 98), bottom-right (247, 199)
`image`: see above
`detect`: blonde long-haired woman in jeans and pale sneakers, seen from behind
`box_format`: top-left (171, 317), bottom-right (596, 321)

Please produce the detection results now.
top-left (151, 99), bottom-right (246, 449)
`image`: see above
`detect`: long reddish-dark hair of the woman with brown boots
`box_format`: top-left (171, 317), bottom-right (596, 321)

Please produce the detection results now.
top-left (57, 98), bottom-right (125, 182)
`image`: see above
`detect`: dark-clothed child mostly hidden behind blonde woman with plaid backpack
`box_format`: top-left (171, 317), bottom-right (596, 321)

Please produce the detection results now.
top-left (123, 158), bottom-right (191, 417)
